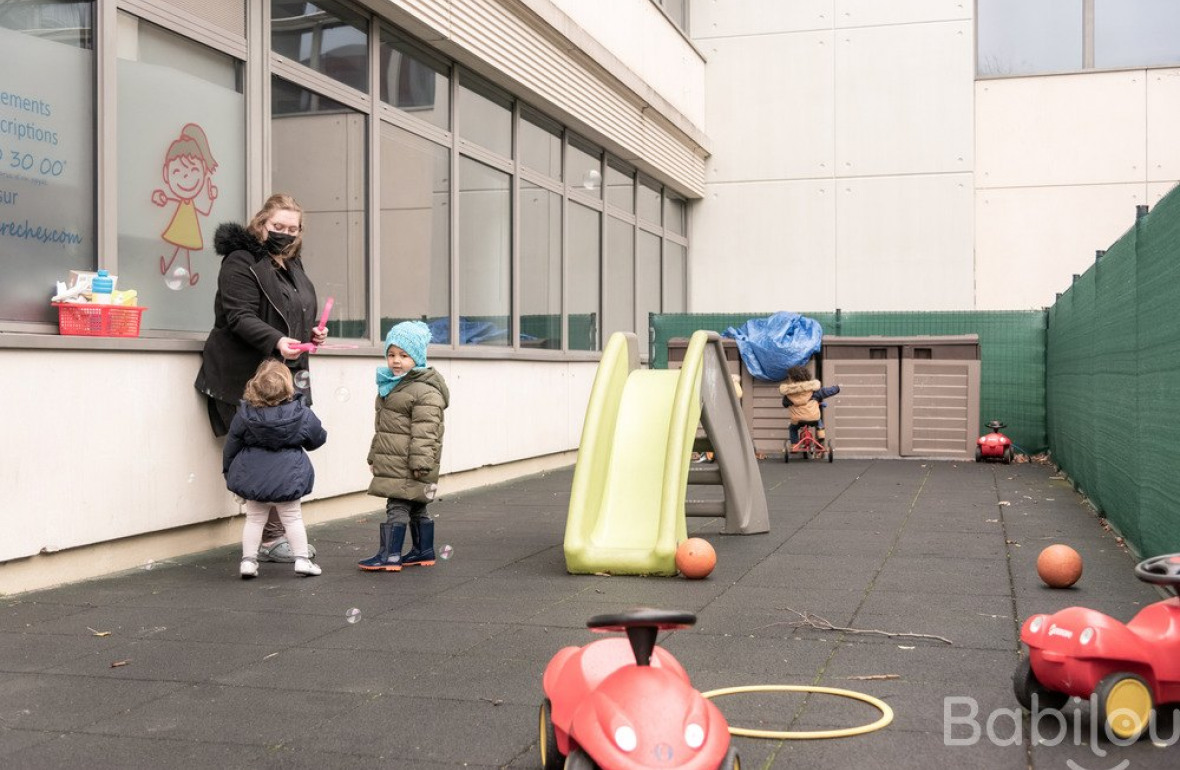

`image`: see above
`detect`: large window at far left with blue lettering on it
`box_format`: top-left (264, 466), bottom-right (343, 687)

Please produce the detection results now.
top-left (0, 2), bottom-right (98, 323)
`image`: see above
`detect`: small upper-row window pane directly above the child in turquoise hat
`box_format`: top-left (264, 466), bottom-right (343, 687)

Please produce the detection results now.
top-left (380, 29), bottom-right (451, 129)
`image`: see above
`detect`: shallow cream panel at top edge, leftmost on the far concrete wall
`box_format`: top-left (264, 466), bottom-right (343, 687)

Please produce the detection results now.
top-left (689, 0), bottom-right (833, 41)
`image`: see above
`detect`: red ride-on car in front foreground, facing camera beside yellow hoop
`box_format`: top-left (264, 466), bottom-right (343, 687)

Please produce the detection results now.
top-left (539, 608), bottom-right (741, 770)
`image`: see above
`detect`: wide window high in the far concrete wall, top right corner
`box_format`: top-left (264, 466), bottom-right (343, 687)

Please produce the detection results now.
top-left (976, 0), bottom-right (1180, 77)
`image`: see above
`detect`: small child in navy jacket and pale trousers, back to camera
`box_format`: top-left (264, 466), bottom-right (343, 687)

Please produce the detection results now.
top-left (222, 358), bottom-right (328, 580)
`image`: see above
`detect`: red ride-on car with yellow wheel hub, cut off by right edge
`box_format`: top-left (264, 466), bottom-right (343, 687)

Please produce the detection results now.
top-left (1012, 553), bottom-right (1180, 741)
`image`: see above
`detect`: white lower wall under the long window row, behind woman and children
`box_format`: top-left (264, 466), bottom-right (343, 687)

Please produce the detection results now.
top-left (0, 349), bottom-right (597, 561)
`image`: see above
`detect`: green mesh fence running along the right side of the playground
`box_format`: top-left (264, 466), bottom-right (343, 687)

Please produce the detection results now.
top-left (1045, 190), bottom-right (1180, 557)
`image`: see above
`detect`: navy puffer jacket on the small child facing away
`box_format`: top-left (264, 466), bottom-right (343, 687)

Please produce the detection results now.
top-left (222, 394), bottom-right (328, 502)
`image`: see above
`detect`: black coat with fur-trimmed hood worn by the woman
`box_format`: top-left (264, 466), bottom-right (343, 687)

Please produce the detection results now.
top-left (194, 223), bottom-right (316, 406)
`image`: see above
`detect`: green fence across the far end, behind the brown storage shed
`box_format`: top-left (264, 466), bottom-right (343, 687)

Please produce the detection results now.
top-left (649, 310), bottom-right (1048, 453)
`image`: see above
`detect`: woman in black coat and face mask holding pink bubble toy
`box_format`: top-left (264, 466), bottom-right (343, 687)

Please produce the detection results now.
top-left (194, 193), bottom-right (328, 561)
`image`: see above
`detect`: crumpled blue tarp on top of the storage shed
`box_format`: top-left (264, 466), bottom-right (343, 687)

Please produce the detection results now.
top-left (721, 310), bottom-right (824, 382)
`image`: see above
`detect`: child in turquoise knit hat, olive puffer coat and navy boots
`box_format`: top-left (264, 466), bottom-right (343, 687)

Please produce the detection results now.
top-left (358, 321), bottom-right (451, 572)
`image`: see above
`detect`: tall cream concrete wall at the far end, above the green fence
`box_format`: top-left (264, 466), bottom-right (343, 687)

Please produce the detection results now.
top-left (689, 0), bottom-right (1180, 312)
